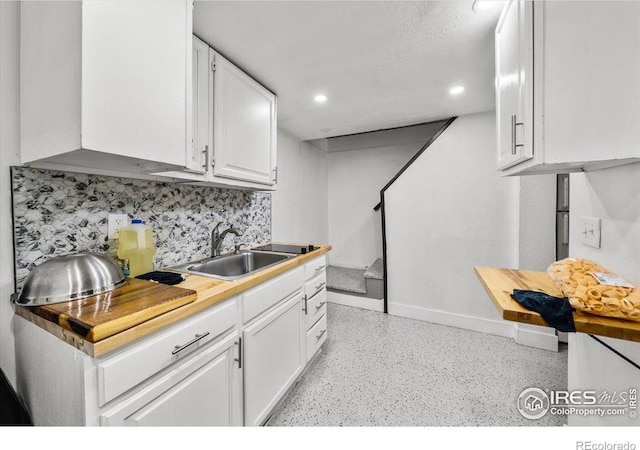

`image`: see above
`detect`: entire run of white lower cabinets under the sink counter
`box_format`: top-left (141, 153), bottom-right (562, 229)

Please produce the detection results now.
top-left (14, 257), bottom-right (327, 426)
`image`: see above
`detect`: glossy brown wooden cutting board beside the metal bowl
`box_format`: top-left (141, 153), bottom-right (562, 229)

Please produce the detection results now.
top-left (27, 278), bottom-right (197, 342)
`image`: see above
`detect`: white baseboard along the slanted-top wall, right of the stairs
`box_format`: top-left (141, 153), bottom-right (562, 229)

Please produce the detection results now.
top-left (387, 303), bottom-right (558, 352)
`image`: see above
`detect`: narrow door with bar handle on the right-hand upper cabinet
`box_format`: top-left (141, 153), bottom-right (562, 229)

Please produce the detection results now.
top-left (495, 0), bottom-right (533, 169)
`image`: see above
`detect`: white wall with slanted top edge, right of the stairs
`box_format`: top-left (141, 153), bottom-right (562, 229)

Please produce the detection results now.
top-left (385, 112), bottom-right (519, 335)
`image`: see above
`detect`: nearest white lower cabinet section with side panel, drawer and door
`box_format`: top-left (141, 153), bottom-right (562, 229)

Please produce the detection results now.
top-left (15, 297), bottom-right (242, 426)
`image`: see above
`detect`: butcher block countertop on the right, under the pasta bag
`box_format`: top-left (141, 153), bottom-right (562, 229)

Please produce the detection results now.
top-left (474, 267), bottom-right (640, 342)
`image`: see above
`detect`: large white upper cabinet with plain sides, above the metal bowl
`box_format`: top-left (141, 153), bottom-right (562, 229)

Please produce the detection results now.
top-left (20, 0), bottom-right (194, 173)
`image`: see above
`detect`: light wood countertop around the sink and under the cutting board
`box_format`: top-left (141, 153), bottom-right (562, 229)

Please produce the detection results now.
top-left (15, 245), bottom-right (331, 358)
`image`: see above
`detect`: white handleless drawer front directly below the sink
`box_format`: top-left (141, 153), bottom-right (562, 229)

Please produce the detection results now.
top-left (242, 267), bottom-right (304, 323)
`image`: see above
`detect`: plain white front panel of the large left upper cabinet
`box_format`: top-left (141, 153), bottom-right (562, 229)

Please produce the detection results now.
top-left (81, 0), bottom-right (192, 166)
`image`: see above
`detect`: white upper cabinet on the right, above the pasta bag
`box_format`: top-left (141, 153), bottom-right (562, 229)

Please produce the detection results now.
top-left (496, 0), bottom-right (640, 175)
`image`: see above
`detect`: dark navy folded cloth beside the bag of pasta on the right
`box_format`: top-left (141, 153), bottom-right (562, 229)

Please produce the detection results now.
top-left (511, 289), bottom-right (576, 333)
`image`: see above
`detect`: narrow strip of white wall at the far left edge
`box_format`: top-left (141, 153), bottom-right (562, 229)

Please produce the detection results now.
top-left (0, 1), bottom-right (20, 386)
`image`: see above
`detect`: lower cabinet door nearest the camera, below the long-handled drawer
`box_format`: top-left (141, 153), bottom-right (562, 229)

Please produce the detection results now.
top-left (100, 332), bottom-right (242, 426)
